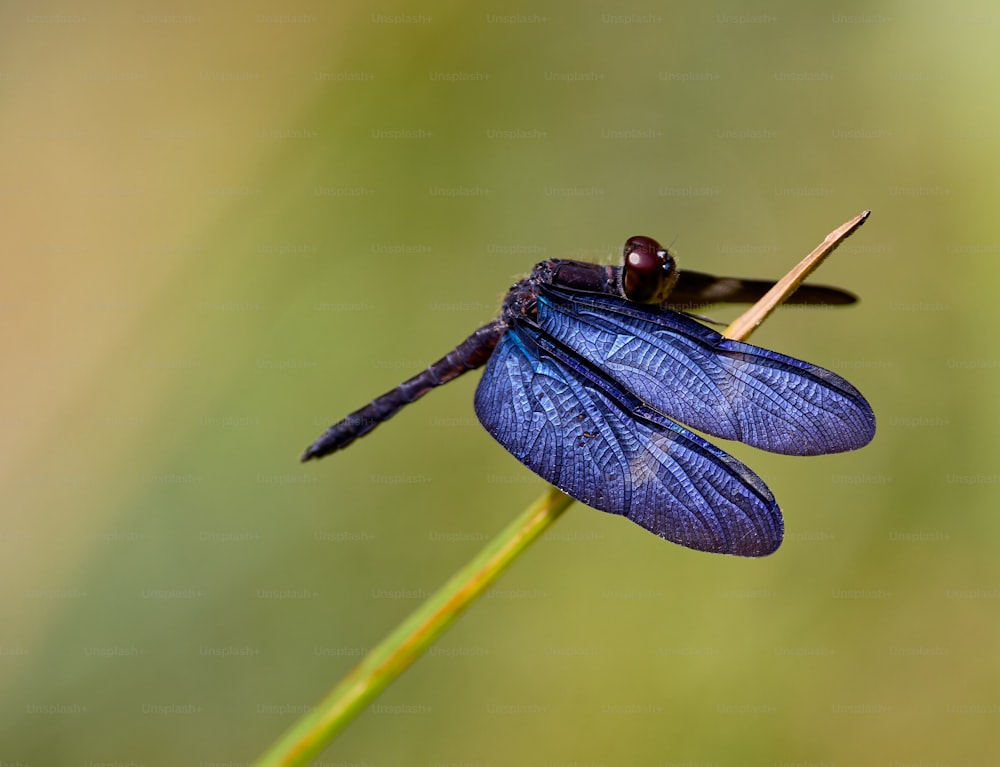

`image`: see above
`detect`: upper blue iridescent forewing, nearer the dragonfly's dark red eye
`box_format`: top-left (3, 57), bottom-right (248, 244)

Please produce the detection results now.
top-left (538, 286), bottom-right (875, 455)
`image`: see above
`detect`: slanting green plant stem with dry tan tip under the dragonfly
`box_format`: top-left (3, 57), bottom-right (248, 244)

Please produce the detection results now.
top-left (255, 210), bottom-right (870, 767)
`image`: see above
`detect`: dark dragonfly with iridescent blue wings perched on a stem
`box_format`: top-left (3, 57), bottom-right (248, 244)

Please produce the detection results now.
top-left (301, 236), bottom-right (875, 557)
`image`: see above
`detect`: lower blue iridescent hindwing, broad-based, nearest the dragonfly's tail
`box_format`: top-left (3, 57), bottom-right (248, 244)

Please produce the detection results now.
top-left (475, 321), bottom-right (784, 556)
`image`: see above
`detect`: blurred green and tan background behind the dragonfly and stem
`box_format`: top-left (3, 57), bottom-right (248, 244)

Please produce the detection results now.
top-left (0, 0), bottom-right (1000, 765)
